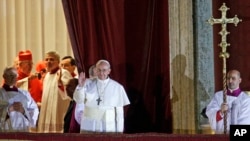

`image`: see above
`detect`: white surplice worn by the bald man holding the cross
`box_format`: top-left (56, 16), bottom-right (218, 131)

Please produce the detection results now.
top-left (206, 91), bottom-right (250, 134)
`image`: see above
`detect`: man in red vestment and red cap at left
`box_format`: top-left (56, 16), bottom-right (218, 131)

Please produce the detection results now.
top-left (17, 50), bottom-right (43, 107)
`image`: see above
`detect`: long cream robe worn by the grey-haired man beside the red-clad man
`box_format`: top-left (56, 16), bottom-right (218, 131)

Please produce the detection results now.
top-left (38, 69), bottom-right (72, 133)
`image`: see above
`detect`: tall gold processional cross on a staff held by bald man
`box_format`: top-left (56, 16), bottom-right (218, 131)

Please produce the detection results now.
top-left (208, 3), bottom-right (242, 134)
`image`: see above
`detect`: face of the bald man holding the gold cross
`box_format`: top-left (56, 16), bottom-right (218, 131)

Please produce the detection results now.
top-left (227, 71), bottom-right (241, 90)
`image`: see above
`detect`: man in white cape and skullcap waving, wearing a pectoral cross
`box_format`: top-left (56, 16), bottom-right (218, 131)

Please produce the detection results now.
top-left (74, 60), bottom-right (130, 133)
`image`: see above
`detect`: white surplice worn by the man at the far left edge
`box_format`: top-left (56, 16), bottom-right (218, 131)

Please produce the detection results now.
top-left (0, 88), bottom-right (39, 132)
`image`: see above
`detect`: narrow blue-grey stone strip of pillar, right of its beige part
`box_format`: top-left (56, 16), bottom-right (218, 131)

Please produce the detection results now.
top-left (193, 0), bottom-right (215, 133)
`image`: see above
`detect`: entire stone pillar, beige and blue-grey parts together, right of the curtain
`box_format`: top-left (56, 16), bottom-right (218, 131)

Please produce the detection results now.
top-left (169, 0), bottom-right (214, 134)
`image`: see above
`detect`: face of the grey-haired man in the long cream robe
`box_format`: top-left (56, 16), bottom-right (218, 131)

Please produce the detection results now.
top-left (45, 55), bottom-right (59, 72)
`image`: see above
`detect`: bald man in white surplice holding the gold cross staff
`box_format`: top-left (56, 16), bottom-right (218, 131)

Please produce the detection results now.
top-left (206, 70), bottom-right (250, 134)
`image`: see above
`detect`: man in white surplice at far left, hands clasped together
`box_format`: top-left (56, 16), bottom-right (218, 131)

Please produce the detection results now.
top-left (0, 67), bottom-right (39, 132)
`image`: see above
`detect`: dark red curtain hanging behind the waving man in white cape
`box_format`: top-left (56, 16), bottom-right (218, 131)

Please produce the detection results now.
top-left (62, 0), bottom-right (172, 133)
